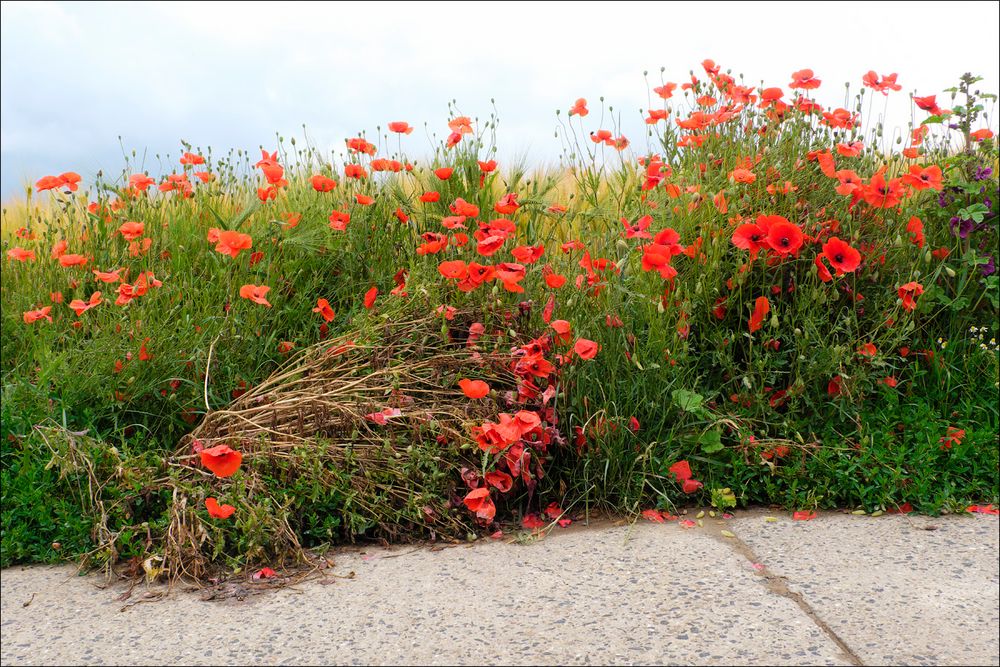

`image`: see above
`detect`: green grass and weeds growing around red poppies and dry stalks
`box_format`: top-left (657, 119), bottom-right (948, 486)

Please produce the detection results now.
top-left (0, 65), bottom-right (1000, 567)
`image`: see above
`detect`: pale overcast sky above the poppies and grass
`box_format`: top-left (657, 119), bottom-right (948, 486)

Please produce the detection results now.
top-left (0, 2), bottom-right (1000, 199)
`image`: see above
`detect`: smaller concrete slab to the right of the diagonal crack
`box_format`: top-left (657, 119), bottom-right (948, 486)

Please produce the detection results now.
top-left (730, 513), bottom-right (1000, 665)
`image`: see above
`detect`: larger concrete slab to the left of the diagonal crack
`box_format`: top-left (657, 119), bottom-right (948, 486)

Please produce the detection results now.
top-left (0, 522), bottom-right (852, 665)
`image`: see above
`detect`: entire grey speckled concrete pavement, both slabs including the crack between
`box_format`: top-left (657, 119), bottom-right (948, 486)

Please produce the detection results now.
top-left (0, 511), bottom-right (1000, 665)
